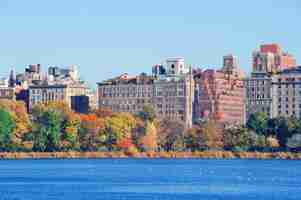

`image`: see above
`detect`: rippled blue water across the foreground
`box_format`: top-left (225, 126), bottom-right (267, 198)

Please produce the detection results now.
top-left (0, 159), bottom-right (301, 200)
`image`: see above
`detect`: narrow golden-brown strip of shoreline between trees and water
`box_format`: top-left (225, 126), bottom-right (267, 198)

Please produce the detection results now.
top-left (0, 151), bottom-right (301, 160)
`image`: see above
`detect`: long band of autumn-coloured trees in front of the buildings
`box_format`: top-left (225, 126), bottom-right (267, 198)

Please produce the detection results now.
top-left (0, 100), bottom-right (301, 153)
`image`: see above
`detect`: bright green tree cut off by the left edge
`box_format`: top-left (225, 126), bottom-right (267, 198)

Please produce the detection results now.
top-left (0, 108), bottom-right (16, 151)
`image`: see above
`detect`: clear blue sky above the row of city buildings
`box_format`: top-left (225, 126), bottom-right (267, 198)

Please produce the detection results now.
top-left (0, 0), bottom-right (301, 85)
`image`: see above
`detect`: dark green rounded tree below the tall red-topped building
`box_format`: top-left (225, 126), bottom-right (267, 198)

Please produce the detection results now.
top-left (247, 112), bottom-right (268, 135)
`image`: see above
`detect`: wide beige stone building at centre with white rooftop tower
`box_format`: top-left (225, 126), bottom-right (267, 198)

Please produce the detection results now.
top-left (98, 58), bottom-right (194, 127)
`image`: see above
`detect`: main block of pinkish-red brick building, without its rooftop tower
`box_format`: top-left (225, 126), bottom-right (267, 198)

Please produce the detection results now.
top-left (194, 70), bottom-right (245, 124)
